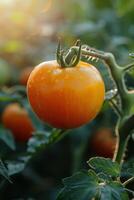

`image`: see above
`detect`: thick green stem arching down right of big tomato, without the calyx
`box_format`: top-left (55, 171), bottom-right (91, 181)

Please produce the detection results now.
top-left (66, 46), bottom-right (134, 164)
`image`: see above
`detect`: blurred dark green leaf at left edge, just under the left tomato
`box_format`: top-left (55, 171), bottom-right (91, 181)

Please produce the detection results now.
top-left (0, 128), bottom-right (15, 150)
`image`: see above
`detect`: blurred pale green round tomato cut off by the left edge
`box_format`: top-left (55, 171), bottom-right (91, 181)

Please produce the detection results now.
top-left (0, 59), bottom-right (11, 86)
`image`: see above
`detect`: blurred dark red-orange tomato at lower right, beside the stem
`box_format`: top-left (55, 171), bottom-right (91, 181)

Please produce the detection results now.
top-left (91, 128), bottom-right (116, 158)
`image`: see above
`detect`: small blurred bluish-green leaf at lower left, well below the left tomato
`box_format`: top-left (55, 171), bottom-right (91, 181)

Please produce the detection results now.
top-left (7, 161), bottom-right (25, 176)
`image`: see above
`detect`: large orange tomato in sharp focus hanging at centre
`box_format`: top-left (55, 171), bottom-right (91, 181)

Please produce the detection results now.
top-left (27, 60), bottom-right (105, 129)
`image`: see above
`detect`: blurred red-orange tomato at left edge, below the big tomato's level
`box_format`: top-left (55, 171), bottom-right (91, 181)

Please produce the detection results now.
top-left (2, 103), bottom-right (34, 142)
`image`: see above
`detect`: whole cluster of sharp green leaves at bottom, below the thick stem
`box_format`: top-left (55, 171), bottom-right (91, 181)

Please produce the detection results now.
top-left (57, 157), bottom-right (129, 200)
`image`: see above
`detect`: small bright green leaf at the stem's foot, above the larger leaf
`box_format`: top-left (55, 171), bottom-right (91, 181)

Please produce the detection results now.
top-left (87, 157), bottom-right (120, 177)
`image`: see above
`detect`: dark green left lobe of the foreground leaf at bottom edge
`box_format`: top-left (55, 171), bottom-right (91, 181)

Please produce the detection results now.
top-left (57, 171), bottom-right (98, 200)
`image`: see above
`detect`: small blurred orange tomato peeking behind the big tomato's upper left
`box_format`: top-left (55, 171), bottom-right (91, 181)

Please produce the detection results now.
top-left (20, 67), bottom-right (33, 86)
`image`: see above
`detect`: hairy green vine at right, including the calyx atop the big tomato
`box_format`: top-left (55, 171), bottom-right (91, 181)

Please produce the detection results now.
top-left (57, 40), bottom-right (134, 163)
